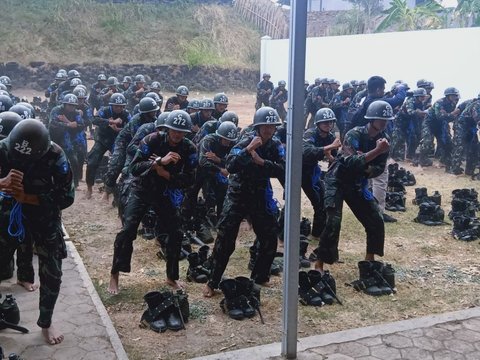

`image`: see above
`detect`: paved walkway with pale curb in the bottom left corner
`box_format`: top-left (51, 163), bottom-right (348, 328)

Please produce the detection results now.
top-left (0, 241), bottom-right (128, 360)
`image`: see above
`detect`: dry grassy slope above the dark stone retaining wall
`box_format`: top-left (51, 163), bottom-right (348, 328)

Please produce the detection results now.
top-left (0, 0), bottom-right (261, 68)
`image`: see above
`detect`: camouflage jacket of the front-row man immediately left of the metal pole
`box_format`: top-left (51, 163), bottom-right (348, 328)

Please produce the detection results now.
top-left (226, 133), bottom-right (285, 194)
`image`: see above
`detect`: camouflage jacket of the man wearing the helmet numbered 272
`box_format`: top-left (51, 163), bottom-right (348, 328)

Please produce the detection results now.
top-left (130, 132), bottom-right (198, 198)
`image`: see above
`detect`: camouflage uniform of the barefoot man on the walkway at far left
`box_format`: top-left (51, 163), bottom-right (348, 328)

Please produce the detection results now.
top-left (0, 140), bottom-right (75, 328)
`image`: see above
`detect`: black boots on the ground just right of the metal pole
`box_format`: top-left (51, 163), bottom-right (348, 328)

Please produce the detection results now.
top-left (298, 270), bottom-right (341, 306)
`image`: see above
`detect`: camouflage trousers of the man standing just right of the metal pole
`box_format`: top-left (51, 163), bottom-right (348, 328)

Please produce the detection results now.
top-left (302, 169), bottom-right (326, 237)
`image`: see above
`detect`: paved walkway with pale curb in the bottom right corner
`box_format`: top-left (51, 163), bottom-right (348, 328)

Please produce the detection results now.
top-left (196, 308), bottom-right (480, 360)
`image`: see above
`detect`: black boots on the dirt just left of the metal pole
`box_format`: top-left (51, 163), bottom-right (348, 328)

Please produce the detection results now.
top-left (219, 276), bottom-right (261, 320)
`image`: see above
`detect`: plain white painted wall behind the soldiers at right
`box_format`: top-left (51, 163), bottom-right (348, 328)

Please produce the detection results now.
top-left (260, 27), bottom-right (480, 101)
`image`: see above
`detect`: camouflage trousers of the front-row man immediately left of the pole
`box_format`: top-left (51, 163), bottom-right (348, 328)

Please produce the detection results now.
top-left (208, 188), bottom-right (278, 289)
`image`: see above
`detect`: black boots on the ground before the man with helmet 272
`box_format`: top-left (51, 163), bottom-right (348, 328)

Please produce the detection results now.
top-left (140, 290), bottom-right (190, 332)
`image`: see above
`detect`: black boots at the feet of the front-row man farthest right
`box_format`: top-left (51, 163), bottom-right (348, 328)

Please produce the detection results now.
top-left (349, 260), bottom-right (397, 296)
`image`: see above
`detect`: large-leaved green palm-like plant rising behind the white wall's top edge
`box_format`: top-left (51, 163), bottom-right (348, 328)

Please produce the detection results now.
top-left (375, 0), bottom-right (444, 32)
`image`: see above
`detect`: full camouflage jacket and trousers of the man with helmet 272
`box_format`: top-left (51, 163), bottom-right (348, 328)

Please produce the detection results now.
top-left (111, 132), bottom-right (197, 280)
